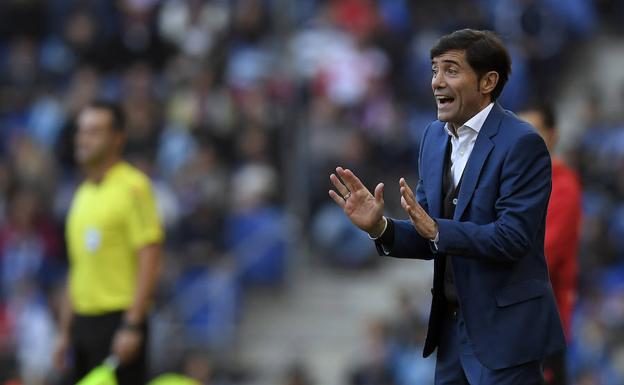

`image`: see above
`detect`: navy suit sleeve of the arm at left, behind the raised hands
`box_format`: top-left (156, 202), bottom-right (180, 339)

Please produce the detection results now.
top-left (375, 125), bottom-right (433, 259)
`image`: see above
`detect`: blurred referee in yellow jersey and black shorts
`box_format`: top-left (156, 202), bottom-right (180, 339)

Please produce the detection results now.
top-left (54, 101), bottom-right (164, 385)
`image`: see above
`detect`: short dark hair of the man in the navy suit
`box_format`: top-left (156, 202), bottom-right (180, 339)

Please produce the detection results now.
top-left (430, 28), bottom-right (511, 100)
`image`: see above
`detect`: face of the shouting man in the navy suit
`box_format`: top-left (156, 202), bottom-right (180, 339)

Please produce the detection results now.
top-left (431, 50), bottom-right (490, 127)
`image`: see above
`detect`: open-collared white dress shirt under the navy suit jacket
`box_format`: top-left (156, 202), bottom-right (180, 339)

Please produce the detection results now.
top-left (444, 103), bottom-right (494, 186)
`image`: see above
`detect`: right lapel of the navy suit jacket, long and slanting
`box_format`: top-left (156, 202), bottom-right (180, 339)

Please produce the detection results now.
top-left (453, 103), bottom-right (504, 220)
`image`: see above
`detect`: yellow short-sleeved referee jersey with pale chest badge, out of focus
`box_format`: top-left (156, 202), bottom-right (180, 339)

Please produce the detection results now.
top-left (66, 162), bottom-right (164, 315)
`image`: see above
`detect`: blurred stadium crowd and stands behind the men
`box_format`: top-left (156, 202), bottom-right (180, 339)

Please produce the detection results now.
top-left (0, 0), bottom-right (624, 385)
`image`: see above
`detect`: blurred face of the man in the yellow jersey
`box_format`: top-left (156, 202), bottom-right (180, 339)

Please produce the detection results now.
top-left (75, 107), bottom-right (122, 166)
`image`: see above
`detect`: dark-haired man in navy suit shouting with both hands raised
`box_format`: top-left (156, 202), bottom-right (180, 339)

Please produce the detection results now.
top-left (329, 29), bottom-right (565, 385)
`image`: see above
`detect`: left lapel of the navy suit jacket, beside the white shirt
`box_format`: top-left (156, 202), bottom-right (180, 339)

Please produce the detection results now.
top-left (423, 126), bottom-right (450, 218)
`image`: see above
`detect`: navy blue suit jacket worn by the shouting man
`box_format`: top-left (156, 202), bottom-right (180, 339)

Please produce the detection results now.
top-left (377, 104), bottom-right (565, 369)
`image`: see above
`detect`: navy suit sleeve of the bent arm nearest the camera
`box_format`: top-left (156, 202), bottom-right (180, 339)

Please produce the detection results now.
top-left (437, 132), bottom-right (551, 262)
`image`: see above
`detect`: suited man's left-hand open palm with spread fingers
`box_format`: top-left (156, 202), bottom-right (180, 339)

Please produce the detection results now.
top-left (329, 167), bottom-right (386, 238)
